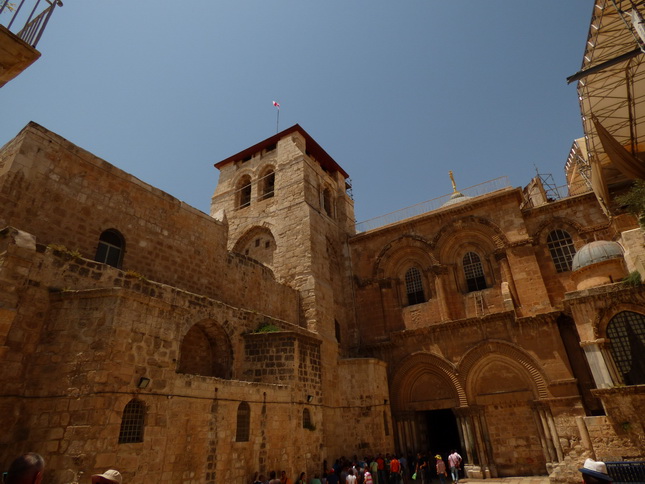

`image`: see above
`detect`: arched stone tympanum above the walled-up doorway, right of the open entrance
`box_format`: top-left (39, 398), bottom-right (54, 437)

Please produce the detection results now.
top-left (459, 340), bottom-right (549, 405)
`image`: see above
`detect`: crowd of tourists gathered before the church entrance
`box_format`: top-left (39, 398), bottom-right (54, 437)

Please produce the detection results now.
top-left (252, 450), bottom-right (462, 484)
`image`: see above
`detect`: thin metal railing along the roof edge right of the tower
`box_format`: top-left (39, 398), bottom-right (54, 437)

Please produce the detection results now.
top-left (356, 176), bottom-right (511, 233)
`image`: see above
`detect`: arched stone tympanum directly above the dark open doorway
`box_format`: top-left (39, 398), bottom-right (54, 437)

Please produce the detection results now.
top-left (390, 353), bottom-right (467, 413)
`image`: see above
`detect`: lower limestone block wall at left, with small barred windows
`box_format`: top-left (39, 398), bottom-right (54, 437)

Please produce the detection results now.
top-left (0, 244), bottom-right (323, 483)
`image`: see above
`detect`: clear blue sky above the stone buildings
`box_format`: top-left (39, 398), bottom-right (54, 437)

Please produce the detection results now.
top-left (0, 0), bottom-right (593, 221)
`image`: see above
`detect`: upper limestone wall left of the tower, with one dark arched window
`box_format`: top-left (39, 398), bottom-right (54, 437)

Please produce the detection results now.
top-left (0, 123), bottom-right (298, 319)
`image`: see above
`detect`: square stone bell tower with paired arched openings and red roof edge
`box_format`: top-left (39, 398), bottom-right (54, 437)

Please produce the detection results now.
top-left (211, 125), bottom-right (354, 351)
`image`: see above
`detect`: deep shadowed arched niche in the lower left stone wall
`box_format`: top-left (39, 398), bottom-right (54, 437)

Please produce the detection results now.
top-left (177, 319), bottom-right (233, 379)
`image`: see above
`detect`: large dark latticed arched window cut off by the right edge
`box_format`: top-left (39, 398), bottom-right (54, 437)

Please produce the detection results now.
top-left (607, 311), bottom-right (645, 385)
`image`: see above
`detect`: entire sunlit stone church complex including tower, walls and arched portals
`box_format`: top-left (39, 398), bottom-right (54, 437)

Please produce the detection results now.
top-left (0, 0), bottom-right (645, 483)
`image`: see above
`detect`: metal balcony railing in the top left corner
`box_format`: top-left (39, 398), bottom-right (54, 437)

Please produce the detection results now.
top-left (0, 0), bottom-right (63, 48)
